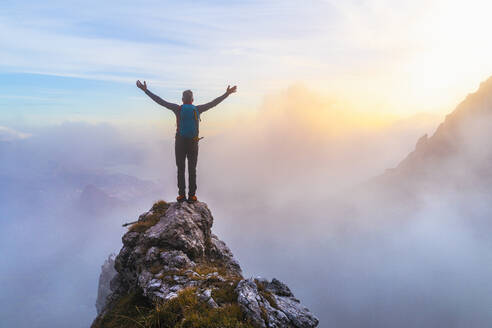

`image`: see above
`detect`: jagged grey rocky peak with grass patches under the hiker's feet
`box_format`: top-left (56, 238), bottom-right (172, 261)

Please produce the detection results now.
top-left (92, 201), bottom-right (318, 328)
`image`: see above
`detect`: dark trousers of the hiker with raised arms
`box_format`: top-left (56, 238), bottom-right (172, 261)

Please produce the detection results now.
top-left (174, 136), bottom-right (198, 196)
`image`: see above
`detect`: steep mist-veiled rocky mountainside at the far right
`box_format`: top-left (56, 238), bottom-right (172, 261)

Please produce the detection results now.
top-left (386, 77), bottom-right (492, 181)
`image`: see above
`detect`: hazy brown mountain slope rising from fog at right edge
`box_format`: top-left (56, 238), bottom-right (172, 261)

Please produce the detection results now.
top-left (371, 77), bottom-right (492, 195)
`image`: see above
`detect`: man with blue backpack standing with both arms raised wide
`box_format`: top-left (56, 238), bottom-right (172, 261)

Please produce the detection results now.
top-left (137, 80), bottom-right (237, 203)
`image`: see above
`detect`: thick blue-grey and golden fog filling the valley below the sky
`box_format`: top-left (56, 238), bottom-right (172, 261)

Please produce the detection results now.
top-left (0, 86), bottom-right (492, 327)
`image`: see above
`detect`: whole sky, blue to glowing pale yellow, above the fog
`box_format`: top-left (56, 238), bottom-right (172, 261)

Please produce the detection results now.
top-left (0, 0), bottom-right (492, 128)
